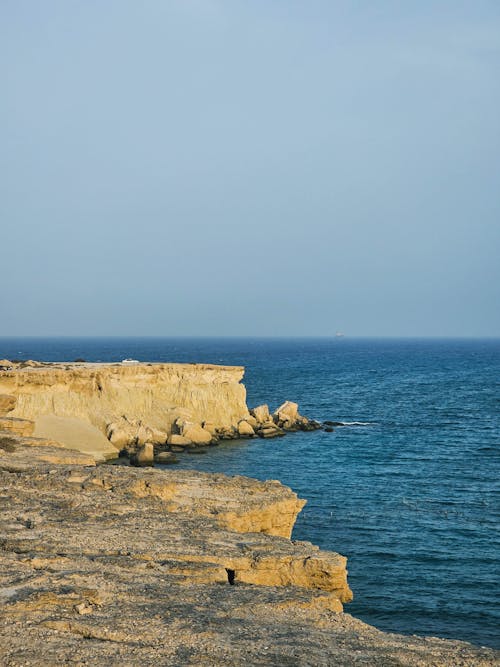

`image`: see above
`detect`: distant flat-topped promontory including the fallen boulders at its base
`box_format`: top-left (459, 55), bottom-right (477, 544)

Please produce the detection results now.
top-left (0, 360), bottom-right (320, 465)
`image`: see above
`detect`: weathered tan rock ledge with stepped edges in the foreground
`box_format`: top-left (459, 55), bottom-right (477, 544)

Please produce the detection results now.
top-left (0, 435), bottom-right (498, 667)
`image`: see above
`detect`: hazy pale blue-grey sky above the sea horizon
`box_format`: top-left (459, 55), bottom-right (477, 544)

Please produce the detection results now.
top-left (0, 0), bottom-right (500, 337)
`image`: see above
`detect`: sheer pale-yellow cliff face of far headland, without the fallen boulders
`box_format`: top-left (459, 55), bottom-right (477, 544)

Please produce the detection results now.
top-left (0, 364), bottom-right (249, 462)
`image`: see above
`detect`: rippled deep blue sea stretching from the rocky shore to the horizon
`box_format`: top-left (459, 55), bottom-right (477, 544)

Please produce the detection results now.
top-left (0, 338), bottom-right (500, 647)
